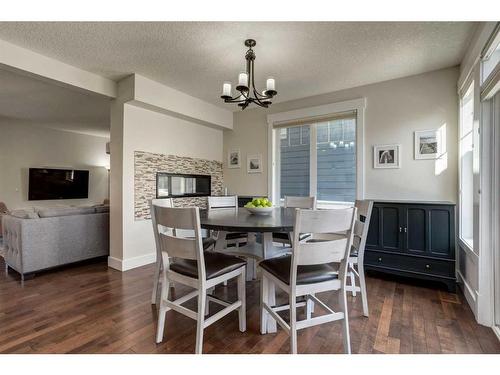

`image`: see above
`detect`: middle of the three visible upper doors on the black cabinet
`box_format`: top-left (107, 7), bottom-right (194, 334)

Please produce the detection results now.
top-left (403, 205), bottom-right (429, 254)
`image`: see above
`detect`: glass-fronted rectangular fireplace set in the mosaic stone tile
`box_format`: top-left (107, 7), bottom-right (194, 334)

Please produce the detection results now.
top-left (156, 172), bottom-right (212, 198)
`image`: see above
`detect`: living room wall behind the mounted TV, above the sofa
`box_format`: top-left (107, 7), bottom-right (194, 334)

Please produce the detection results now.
top-left (0, 123), bottom-right (109, 209)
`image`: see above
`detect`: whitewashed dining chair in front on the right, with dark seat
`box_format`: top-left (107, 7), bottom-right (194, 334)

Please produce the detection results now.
top-left (260, 207), bottom-right (356, 353)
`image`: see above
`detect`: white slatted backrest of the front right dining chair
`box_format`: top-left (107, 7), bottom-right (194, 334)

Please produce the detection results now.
top-left (291, 207), bottom-right (356, 268)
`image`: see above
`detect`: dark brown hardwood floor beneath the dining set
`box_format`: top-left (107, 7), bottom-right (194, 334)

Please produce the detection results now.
top-left (0, 258), bottom-right (500, 353)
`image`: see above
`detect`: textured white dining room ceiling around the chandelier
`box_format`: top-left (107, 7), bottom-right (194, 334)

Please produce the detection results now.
top-left (0, 22), bottom-right (475, 110)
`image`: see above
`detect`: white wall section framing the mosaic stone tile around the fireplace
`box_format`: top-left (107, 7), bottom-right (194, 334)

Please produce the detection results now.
top-left (110, 104), bottom-right (222, 270)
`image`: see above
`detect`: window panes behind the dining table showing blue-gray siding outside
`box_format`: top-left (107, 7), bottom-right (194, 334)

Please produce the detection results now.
top-left (274, 117), bottom-right (356, 203)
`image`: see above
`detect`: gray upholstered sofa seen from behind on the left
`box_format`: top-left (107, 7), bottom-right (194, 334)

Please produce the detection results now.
top-left (2, 206), bottom-right (109, 280)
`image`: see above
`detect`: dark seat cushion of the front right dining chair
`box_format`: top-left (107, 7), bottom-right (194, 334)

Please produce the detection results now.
top-left (259, 255), bottom-right (338, 285)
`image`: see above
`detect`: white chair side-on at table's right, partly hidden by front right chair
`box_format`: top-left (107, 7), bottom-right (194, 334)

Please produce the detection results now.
top-left (347, 200), bottom-right (373, 316)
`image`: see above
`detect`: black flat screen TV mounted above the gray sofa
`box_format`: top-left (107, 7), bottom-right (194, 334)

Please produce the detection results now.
top-left (28, 168), bottom-right (89, 201)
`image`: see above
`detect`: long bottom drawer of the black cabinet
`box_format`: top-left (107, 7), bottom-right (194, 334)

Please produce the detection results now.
top-left (365, 250), bottom-right (455, 278)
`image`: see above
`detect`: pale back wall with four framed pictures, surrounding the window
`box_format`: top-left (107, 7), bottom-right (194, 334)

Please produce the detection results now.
top-left (224, 67), bottom-right (458, 202)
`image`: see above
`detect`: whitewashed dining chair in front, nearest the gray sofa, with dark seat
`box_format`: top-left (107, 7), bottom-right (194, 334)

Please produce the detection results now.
top-left (152, 204), bottom-right (246, 354)
